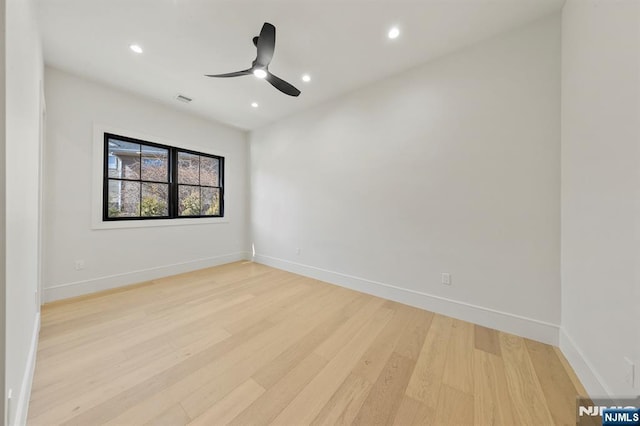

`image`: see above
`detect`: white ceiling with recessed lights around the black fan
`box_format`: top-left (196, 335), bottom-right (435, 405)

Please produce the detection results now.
top-left (38, 0), bottom-right (564, 129)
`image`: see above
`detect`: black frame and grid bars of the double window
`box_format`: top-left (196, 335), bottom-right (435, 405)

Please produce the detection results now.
top-left (102, 132), bottom-right (225, 222)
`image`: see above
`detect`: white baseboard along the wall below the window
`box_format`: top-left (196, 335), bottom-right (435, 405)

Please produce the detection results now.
top-left (44, 252), bottom-right (251, 302)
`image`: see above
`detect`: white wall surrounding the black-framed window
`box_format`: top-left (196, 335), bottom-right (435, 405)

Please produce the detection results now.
top-left (44, 68), bottom-right (248, 300)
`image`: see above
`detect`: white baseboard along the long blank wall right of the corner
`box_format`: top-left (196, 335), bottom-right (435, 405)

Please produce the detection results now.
top-left (253, 255), bottom-right (559, 346)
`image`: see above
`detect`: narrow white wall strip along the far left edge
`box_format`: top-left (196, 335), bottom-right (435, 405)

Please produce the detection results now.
top-left (5, 0), bottom-right (42, 424)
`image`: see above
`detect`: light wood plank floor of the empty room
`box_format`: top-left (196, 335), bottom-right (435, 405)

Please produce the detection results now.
top-left (28, 262), bottom-right (584, 426)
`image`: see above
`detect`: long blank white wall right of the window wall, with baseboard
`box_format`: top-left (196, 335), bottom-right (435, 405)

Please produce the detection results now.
top-left (250, 16), bottom-right (560, 343)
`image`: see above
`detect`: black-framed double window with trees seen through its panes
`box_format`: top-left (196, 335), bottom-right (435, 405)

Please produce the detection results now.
top-left (102, 133), bottom-right (224, 221)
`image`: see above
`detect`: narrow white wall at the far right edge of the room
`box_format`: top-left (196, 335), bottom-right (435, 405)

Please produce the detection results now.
top-left (561, 0), bottom-right (640, 396)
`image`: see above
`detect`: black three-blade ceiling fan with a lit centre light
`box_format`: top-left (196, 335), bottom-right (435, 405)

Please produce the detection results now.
top-left (207, 22), bottom-right (300, 96)
